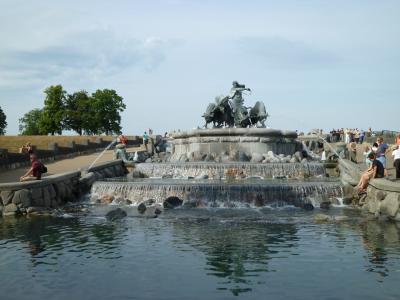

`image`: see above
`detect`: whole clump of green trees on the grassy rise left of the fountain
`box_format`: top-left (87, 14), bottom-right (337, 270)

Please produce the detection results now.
top-left (19, 85), bottom-right (126, 135)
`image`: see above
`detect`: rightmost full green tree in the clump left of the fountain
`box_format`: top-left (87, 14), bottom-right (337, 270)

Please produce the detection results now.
top-left (92, 89), bottom-right (126, 135)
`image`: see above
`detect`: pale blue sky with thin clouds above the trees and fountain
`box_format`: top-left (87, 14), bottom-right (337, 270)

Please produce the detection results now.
top-left (0, 0), bottom-right (400, 135)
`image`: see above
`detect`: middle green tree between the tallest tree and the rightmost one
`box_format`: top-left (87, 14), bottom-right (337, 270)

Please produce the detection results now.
top-left (64, 91), bottom-right (94, 135)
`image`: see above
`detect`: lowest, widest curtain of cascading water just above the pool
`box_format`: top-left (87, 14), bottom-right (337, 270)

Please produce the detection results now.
top-left (92, 179), bottom-right (343, 207)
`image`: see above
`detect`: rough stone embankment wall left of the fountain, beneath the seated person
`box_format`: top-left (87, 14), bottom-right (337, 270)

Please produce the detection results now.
top-left (0, 160), bottom-right (127, 216)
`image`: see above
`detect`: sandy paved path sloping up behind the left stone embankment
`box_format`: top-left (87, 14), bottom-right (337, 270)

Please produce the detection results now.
top-left (0, 148), bottom-right (141, 183)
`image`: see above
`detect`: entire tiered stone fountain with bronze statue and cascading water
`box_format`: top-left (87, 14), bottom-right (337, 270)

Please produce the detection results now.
top-left (91, 82), bottom-right (342, 209)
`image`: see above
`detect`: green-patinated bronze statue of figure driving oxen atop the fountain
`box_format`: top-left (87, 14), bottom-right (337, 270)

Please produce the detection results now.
top-left (203, 81), bottom-right (268, 128)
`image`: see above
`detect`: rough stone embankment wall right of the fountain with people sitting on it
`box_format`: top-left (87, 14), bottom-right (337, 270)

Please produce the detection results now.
top-left (339, 159), bottom-right (400, 221)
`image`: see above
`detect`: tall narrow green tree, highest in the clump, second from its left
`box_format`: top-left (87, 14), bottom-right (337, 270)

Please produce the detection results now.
top-left (39, 85), bottom-right (67, 135)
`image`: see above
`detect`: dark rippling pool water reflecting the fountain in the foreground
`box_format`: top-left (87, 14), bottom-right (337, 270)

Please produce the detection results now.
top-left (0, 208), bottom-right (400, 300)
